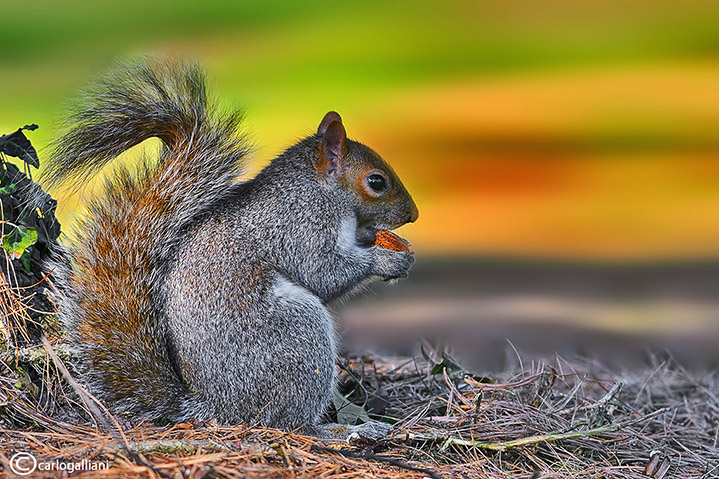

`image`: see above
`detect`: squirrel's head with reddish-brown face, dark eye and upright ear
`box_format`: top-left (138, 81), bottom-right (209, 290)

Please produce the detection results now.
top-left (314, 111), bottom-right (419, 245)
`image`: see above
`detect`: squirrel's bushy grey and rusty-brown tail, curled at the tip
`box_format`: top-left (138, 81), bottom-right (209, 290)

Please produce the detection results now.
top-left (44, 60), bottom-right (248, 419)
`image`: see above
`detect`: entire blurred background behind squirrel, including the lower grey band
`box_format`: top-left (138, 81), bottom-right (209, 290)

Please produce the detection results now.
top-left (0, 0), bottom-right (719, 367)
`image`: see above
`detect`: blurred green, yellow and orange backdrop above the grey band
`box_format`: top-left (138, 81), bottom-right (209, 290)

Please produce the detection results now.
top-left (0, 0), bottom-right (719, 260)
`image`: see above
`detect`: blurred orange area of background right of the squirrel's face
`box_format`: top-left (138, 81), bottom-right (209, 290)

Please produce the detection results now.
top-left (363, 65), bottom-right (719, 259)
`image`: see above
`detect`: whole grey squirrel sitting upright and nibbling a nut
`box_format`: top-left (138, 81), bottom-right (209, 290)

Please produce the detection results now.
top-left (44, 60), bottom-right (418, 429)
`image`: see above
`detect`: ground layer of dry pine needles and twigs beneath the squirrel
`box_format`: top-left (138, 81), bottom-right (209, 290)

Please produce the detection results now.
top-left (0, 262), bottom-right (719, 479)
